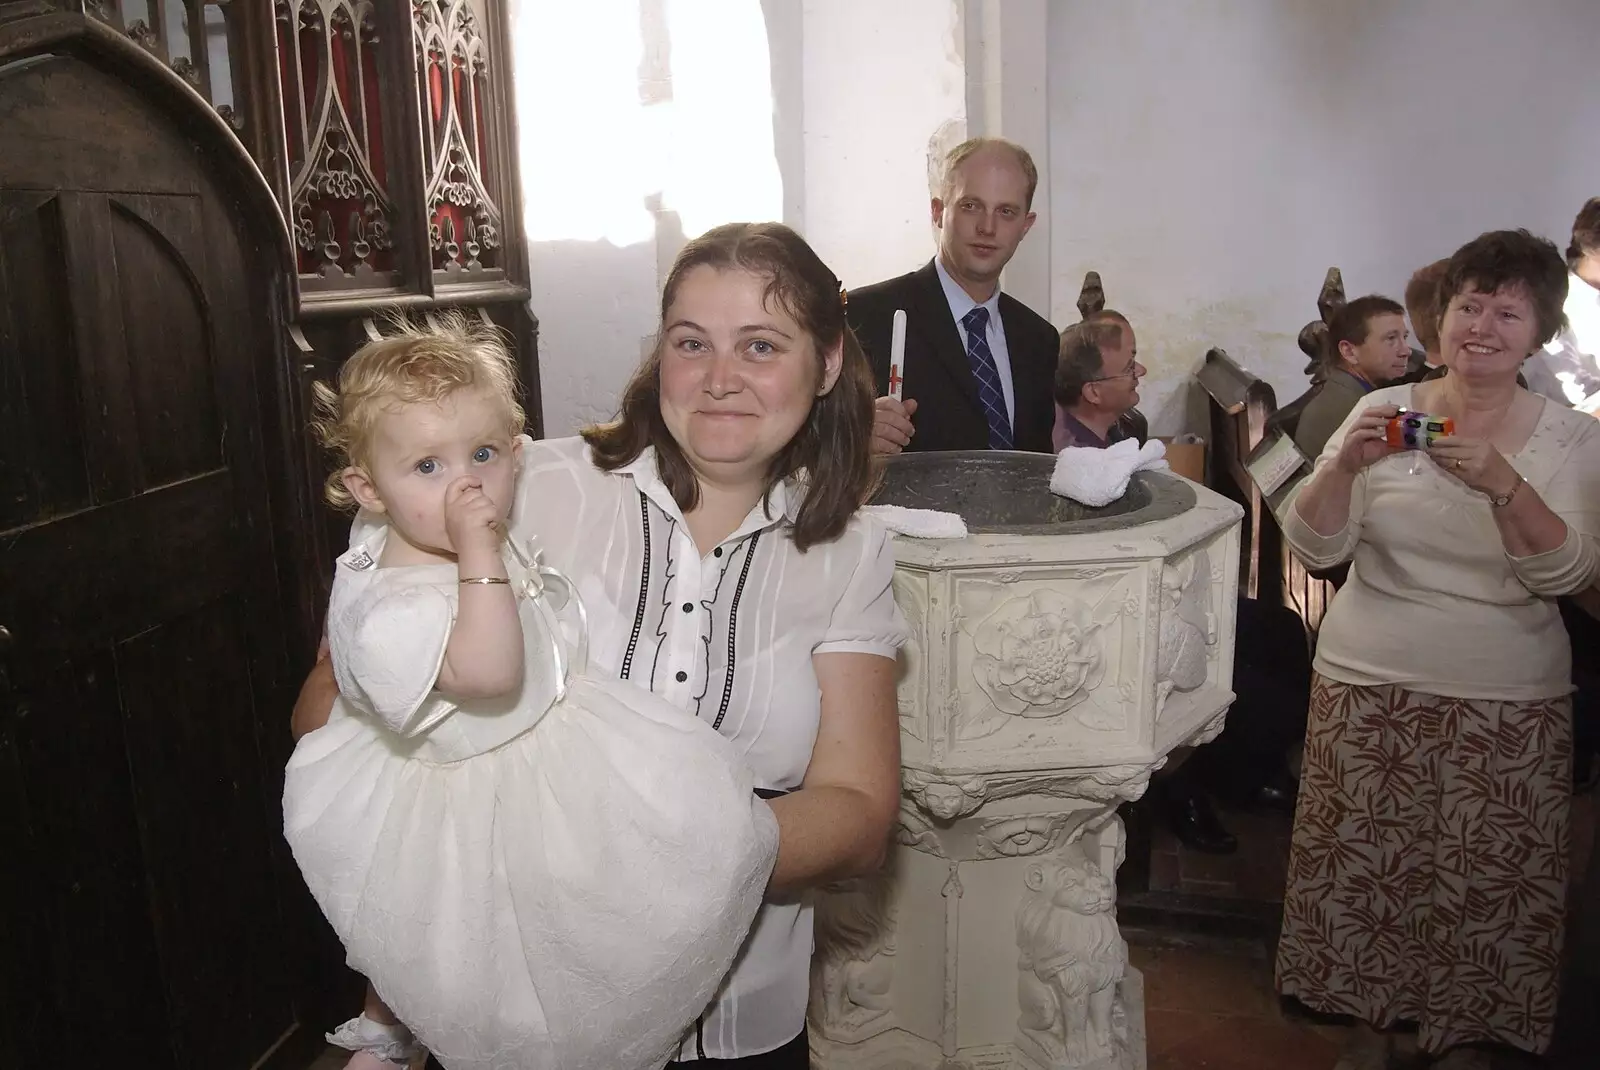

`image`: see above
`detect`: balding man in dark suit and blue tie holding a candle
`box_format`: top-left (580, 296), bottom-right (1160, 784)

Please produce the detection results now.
top-left (848, 138), bottom-right (1059, 453)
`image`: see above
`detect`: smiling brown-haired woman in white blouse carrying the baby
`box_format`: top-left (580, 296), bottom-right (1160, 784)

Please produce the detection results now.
top-left (294, 224), bottom-right (906, 1070)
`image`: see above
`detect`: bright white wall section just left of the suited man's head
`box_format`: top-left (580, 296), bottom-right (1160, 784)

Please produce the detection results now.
top-left (790, 0), bottom-right (966, 286)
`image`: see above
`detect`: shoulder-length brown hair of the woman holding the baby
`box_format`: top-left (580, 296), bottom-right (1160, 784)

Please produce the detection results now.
top-left (582, 222), bottom-right (878, 550)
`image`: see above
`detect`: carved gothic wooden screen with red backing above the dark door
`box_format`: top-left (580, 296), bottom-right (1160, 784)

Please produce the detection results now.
top-left (140, 0), bottom-right (526, 315)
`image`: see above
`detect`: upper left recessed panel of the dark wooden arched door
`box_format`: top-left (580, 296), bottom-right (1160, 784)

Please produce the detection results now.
top-left (0, 190), bottom-right (90, 531)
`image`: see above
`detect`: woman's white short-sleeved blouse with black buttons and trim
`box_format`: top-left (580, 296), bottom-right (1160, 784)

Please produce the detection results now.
top-left (512, 438), bottom-right (909, 1060)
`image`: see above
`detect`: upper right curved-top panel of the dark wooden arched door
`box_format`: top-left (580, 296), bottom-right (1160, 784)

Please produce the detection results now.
top-left (110, 194), bottom-right (220, 486)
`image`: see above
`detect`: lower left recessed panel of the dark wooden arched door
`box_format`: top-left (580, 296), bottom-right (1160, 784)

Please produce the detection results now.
top-left (0, 648), bottom-right (173, 1070)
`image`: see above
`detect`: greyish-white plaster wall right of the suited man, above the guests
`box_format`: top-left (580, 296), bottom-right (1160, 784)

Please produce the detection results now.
top-left (1048, 0), bottom-right (1600, 433)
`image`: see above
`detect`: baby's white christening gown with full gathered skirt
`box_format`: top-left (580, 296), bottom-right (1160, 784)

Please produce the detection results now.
top-left (283, 533), bottom-right (778, 1070)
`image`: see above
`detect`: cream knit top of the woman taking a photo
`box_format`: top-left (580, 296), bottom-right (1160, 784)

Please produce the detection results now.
top-left (1283, 385), bottom-right (1600, 701)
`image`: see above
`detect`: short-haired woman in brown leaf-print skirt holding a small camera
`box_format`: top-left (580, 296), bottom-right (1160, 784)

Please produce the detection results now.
top-left (1277, 230), bottom-right (1600, 1070)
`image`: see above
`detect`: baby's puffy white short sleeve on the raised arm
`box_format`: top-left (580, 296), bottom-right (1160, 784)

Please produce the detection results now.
top-left (328, 584), bottom-right (456, 736)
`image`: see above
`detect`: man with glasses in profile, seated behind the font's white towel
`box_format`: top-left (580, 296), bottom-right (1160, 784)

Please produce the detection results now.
top-left (1053, 309), bottom-right (1144, 453)
